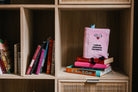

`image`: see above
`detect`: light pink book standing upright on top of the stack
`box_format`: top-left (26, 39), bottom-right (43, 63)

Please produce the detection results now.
top-left (83, 27), bottom-right (110, 58)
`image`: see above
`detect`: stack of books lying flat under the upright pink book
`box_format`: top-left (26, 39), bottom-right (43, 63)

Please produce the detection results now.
top-left (66, 57), bottom-right (113, 77)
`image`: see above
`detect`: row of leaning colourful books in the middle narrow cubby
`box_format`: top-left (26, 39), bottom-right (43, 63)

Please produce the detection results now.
top-left (26, 39), bottom-right (55, 75)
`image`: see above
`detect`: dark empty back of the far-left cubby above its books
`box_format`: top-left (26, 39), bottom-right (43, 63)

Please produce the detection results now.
top-left (0, 9), bottom-right (20, 72)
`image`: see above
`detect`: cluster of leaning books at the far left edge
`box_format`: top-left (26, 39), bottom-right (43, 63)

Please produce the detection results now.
top-left (0, 39), bottom-right (11, 74)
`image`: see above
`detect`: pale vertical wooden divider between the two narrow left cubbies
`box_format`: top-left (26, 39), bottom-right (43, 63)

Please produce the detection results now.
top-left (21, 8), bottom-right (33, 75)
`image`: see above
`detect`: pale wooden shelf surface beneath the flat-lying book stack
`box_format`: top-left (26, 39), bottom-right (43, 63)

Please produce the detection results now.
top-left (57, 68), bottom-right (129, 80)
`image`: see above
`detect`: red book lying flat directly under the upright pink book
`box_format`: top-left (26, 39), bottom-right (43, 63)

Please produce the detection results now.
top-left (77, 57), bottom-right (113, 64)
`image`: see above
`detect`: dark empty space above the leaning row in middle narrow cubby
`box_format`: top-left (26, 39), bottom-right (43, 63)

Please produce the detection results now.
top-left (23, 9), bottom-right (55, 75)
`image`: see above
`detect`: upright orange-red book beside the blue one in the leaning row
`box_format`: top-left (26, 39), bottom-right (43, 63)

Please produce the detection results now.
top-left (46, 40), bottom-right (53, 74)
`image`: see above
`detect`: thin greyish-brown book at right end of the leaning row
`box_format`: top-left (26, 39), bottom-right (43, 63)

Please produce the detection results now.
top-left (51, 41), bottom-right (55, 75)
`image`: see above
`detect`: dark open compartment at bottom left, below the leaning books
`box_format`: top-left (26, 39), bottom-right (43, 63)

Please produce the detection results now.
top-left (0, 79), bottom-right (54, 92)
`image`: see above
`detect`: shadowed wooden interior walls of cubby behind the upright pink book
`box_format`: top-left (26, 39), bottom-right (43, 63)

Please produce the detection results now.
top-left (60, 9), bottom-right (131, 74)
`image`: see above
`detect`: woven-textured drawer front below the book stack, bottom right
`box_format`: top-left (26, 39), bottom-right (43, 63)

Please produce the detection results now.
top-left (59, 82), bottom-right (128, 92)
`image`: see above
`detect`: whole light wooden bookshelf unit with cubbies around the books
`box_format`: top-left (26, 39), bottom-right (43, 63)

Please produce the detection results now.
top-left (0, 0), bottom-right (134, 92)
